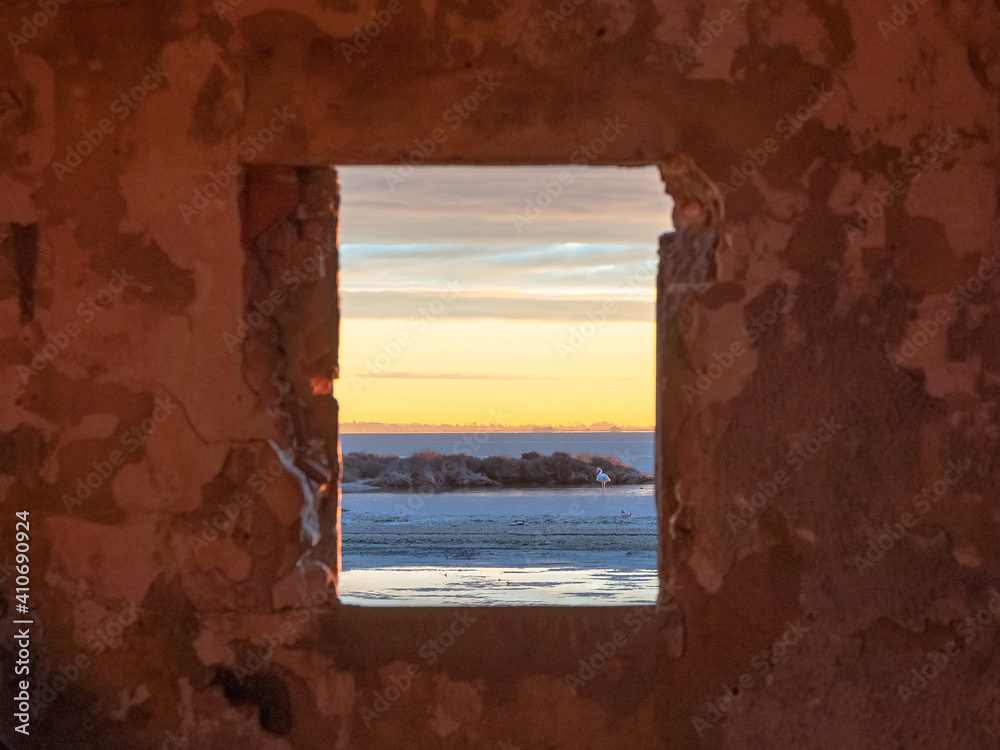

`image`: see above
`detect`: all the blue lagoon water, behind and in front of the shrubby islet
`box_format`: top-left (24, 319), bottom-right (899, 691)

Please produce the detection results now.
top-left (340, 433), bottom-right (658, 606)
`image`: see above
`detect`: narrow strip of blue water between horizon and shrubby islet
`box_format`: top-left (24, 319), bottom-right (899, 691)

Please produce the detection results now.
top-left (340, 432), bottom-right (654, 474)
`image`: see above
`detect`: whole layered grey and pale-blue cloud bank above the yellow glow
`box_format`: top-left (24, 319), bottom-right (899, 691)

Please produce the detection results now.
top-left (338, 165), bottom-right (672, 321)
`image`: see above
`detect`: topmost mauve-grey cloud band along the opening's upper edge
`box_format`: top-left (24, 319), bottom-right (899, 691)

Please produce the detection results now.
top-left (337, 165), bottom-right (673, 247)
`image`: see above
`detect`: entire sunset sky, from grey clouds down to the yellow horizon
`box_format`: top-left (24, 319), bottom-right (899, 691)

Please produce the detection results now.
top-left (334, 165), bottom-right (673, 426)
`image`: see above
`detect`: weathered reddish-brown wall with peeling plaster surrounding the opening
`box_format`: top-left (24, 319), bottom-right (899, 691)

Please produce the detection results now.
top-left (0, 0), bottom-right (1000, 750)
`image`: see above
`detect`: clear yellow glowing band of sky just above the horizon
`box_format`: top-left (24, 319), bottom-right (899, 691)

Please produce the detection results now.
top-left (334, 319), bottom-right (655, 425)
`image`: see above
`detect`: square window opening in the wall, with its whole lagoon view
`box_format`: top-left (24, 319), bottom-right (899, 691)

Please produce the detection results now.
top-left (334, 165), bottom-right (673, 606)
